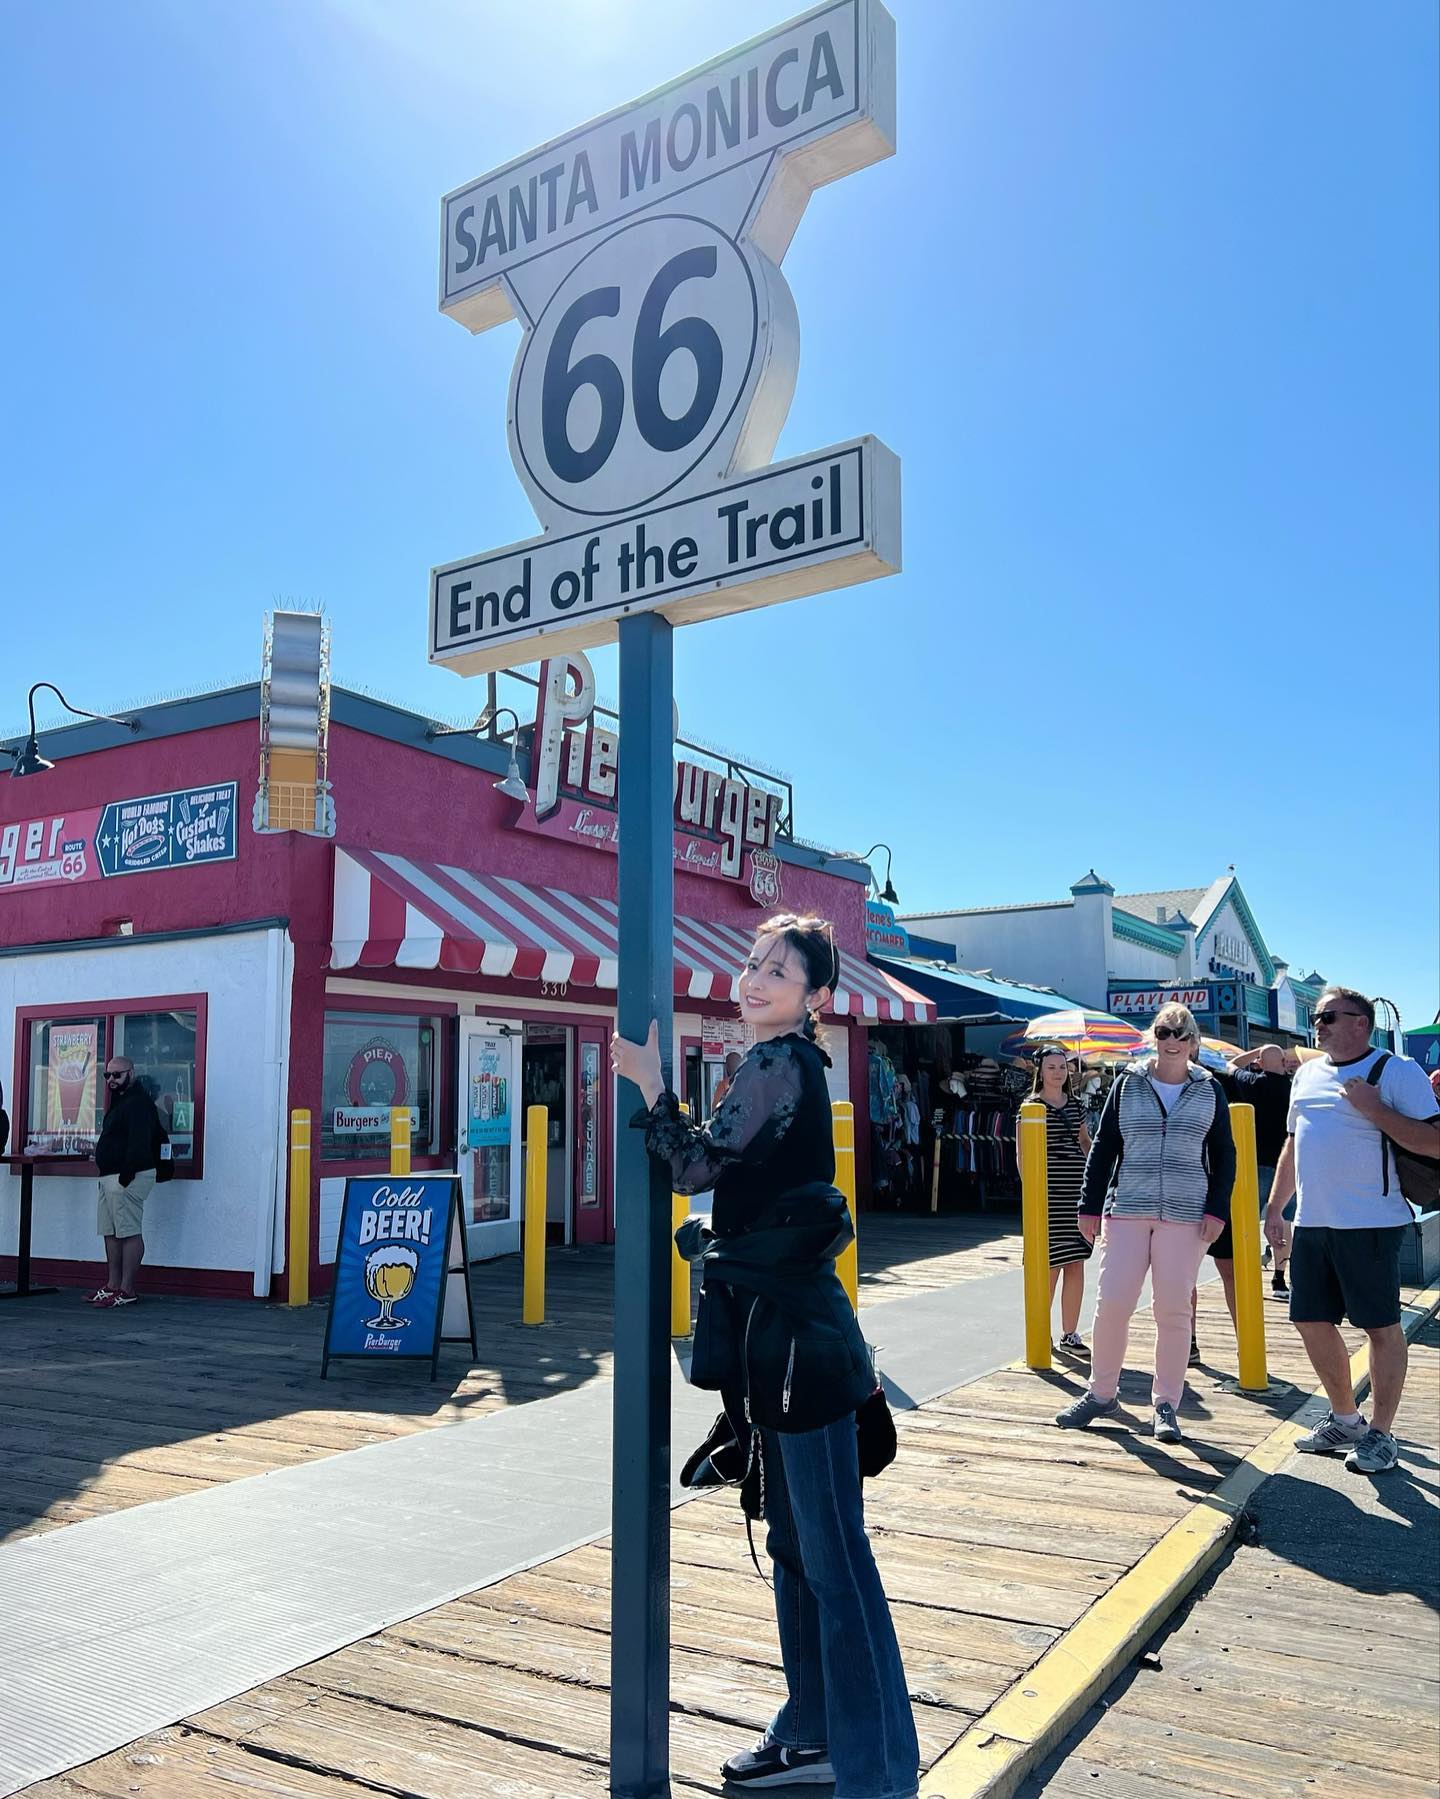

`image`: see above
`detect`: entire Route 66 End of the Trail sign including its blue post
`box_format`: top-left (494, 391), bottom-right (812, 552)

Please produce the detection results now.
top-left (430, 0), bottom-right (900, 1799)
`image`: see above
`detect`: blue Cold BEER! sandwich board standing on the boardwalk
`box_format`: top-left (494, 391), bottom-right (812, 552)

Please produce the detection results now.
top-left (320, 1175), bottom-right (473, 1374)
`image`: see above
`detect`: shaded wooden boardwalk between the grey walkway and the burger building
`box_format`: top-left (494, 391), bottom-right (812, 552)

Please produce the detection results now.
top-left (0, 1214), bottom-right (1021, 1540)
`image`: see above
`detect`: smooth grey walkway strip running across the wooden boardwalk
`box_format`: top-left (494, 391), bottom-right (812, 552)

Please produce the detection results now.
top-left (0, 1272), bottom-right (1051, 1795)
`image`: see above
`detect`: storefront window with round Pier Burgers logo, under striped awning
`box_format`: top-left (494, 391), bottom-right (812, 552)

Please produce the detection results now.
top-left (320, 1011), bottom-right (443, 1162)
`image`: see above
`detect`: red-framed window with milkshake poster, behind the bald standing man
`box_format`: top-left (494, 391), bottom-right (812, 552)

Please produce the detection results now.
top-left (16, 997), bottom-right (205, 1175)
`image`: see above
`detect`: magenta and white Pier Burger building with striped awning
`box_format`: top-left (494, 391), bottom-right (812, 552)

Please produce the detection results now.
top-left (0, 684), bottom-right (932, 1295)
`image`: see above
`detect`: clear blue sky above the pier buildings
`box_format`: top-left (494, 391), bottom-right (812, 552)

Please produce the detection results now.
top-left (0, 0), bottom-right (1440, 1022)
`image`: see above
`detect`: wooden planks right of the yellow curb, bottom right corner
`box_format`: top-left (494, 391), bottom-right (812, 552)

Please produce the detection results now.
top-left (1024, 1320), bottom-right (1440, 1799)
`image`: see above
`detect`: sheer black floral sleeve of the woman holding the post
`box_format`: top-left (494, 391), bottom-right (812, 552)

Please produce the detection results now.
top-left (632, 1038), bottom-right (801, 1193)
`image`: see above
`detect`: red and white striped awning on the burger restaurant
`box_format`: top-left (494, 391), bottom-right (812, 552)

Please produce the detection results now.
top-left (329, 849), bottom-right (934, 1024)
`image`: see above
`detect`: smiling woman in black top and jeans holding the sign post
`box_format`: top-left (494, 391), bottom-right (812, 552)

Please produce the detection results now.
top-left (610, 914), bottom-right (920, 1799)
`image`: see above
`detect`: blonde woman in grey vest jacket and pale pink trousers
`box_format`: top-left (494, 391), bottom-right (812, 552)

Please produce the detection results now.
top-left (1055, 1006), bottom-right (1235, 1443)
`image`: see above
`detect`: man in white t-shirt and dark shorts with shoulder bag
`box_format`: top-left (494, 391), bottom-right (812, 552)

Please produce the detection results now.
top-left (1265, 988), bottom-right (1440, 1473)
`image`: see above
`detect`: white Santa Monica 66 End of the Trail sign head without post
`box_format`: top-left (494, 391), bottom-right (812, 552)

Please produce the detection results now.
top-left (430, 0), bottom-right (900, 675)
